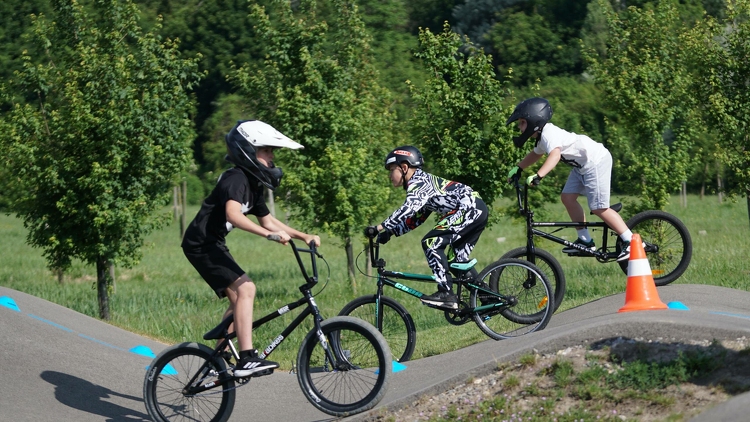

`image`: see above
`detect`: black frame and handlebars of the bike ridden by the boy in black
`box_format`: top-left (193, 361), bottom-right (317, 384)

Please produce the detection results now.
top-left (186, 240), bottom-right (336, 394)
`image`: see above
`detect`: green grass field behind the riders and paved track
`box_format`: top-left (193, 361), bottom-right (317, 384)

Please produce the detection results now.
top-left (0, 196), bottom-right (750, 368)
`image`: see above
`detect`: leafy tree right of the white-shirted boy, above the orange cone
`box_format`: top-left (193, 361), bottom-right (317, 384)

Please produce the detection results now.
top-left (587, 0), bottom-right (701, 209)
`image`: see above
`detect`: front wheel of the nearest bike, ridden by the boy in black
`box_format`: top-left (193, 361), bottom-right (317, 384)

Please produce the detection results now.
top-left (297, 316), bottom-right (393, 417)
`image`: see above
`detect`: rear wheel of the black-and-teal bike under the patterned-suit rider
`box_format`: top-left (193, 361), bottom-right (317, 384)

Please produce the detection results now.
top-left (471, 258), bottom-right (555, 340)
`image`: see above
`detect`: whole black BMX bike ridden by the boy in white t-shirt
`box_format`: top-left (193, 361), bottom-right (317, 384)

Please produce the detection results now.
top-left (502, 179), bottom-right (693, 310)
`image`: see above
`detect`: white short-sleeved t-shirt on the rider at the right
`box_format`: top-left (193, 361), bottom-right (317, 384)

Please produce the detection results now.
top-left (534, 123), bottom-right (607, 168)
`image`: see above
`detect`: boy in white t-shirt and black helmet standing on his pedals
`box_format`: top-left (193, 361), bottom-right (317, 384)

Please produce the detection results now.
top-left (506, 98), bottom-right (633, 261)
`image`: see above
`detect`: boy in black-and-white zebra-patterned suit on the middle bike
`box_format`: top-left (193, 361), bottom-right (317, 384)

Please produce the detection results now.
top-left (368, 146), bottom-right (488, 309)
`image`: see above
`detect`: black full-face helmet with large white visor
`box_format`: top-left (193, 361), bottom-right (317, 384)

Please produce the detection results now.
top-left (224, 120), bottom-right (303, 190)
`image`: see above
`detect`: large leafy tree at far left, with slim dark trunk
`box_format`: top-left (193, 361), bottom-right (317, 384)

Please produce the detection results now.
top-left (0, 0), bottom-right (200, 319)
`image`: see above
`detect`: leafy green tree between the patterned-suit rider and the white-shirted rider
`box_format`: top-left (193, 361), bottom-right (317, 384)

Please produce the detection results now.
top-left (411, 23), bottom-right (522, 223)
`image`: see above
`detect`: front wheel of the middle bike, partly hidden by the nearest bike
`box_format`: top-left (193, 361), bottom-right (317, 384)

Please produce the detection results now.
top-left (339, 295), bottom-right (417, 362)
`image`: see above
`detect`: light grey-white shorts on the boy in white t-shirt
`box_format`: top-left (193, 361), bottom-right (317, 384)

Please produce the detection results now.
top-left (562, 151), bottom-right (612, 210)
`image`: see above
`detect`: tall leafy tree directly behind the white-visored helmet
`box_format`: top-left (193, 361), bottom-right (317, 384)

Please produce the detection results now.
top-left (231, 0), bottom-right (394, 284)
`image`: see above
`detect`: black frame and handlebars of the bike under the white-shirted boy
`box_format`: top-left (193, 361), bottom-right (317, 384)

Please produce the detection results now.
top-left (515, 180), bottom-right (621, 263)
